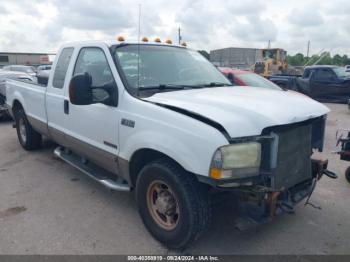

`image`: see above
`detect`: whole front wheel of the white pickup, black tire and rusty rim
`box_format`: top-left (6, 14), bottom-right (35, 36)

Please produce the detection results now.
top-left (136, 159), bottom-right (211, 249)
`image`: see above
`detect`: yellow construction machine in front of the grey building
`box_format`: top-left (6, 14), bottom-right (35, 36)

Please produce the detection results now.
top-left (254, 48), bottom-right (288, 77)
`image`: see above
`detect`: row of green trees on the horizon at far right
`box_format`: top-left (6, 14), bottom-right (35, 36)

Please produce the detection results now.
top-left (288, 52), bottom-right (350, 66)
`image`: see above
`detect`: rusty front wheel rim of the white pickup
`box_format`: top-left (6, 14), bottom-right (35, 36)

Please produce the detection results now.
top-left (147, 180), bottom-right (180, 231)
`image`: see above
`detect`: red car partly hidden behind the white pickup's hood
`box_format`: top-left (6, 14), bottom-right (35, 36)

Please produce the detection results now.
top-left (219, 67), bottom-right (281, 90)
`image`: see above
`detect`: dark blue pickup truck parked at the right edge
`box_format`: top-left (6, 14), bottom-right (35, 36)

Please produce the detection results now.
top-left (269, 65), bottom-right (350, 103)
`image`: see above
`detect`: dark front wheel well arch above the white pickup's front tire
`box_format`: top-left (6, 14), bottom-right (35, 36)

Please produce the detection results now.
top-left (129, 148), bottom-right (189, 186)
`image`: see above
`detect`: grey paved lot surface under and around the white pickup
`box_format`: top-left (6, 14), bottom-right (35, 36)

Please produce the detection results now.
top-left (0, 104), bottom-right (350, 254)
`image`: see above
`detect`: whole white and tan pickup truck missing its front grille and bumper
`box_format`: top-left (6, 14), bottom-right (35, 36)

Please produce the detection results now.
top-left (7, 42), bottom-right (332, 248)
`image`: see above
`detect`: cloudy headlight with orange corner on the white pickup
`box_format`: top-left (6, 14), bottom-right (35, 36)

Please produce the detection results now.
top-left (210, 142), bottom-right (261, 179)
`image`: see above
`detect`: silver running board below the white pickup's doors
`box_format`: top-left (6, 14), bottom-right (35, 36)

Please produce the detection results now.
top-left (54, 147), bottom-right (130, 191)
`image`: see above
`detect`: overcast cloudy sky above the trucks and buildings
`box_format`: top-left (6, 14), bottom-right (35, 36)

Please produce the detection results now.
top-left (0, 0), bottom-right (350, 55)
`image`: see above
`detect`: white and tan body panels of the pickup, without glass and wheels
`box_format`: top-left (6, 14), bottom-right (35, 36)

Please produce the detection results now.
top-left (7, 42), bottom-right (329, 249)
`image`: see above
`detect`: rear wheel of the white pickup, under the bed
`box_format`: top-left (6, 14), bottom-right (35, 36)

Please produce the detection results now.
top-left (15, 109), bottom-right (42, 151)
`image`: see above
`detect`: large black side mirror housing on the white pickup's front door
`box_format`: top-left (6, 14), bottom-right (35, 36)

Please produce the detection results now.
top-left (69, 73), bottom-right (92, 106)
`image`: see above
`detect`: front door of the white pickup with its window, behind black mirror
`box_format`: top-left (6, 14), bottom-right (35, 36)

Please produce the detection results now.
top-left (61, 47), bottom-right (120, 174)
